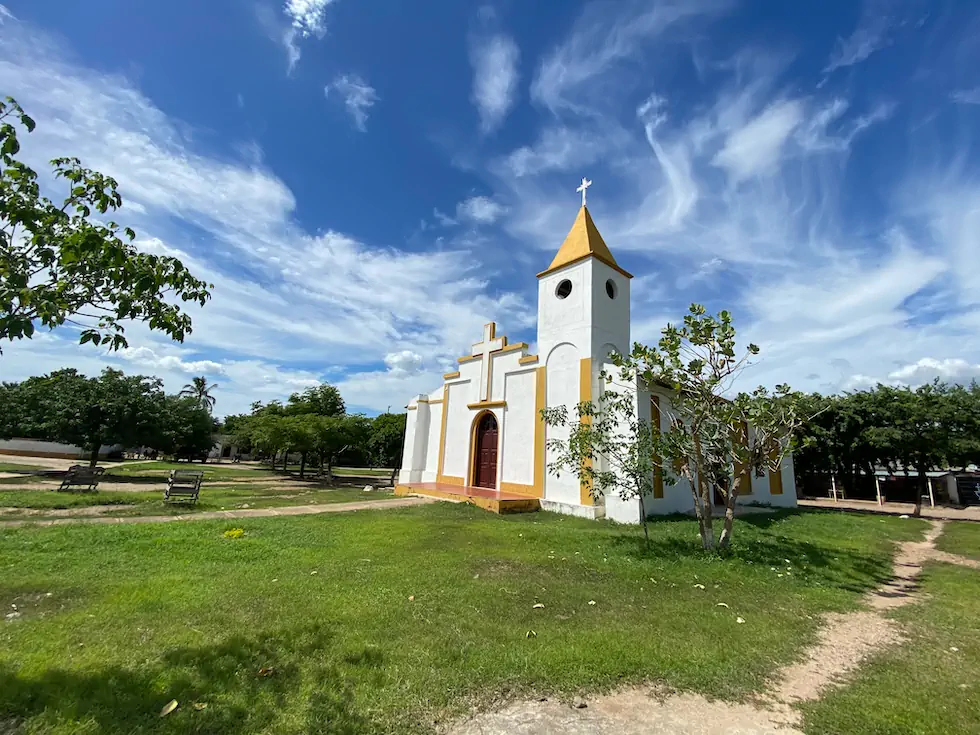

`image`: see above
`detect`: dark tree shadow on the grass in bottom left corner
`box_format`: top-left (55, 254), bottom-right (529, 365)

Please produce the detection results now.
top-left (0, 627), bottom-right (383, 733)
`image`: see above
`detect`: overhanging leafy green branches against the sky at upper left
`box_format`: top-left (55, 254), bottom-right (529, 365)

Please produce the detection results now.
top-left (0, 97), bottom-right (213, 350)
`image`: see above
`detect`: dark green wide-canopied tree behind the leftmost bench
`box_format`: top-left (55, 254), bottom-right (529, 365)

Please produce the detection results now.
top-left (4, 368), bottom-right (164, 467)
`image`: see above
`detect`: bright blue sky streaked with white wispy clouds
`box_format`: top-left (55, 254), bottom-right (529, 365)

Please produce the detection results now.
top-left (0, 0), bottom-right (980, 414)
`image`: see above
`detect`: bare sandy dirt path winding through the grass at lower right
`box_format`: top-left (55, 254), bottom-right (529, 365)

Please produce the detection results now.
top-left (449, 521), bottom-right (980, 735)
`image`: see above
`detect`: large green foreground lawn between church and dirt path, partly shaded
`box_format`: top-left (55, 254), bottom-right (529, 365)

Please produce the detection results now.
top-left (0, 504), bottom-right (924, 733)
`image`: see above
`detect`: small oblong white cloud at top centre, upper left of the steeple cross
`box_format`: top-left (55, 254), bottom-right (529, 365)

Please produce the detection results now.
top-left (470, 33), bottom-right (520, 133)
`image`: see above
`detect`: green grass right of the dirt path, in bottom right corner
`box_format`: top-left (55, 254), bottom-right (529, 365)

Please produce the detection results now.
top-left (804, 556), bottom-right (980, 735)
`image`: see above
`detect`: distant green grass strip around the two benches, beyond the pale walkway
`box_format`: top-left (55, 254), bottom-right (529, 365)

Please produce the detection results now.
top-left (0, 483), bottom-right (394, 520)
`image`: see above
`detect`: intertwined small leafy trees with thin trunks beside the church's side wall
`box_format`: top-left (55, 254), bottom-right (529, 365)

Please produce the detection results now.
top-left (543, 304), bottom-right (800, 549)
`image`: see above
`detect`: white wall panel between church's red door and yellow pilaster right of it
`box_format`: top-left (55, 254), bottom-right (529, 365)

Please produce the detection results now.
top-left (499, 368), bottom-right (536, 492)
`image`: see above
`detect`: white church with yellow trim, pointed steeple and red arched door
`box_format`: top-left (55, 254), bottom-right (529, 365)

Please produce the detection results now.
top-left (396, 191), bottom-right (796, 523)
